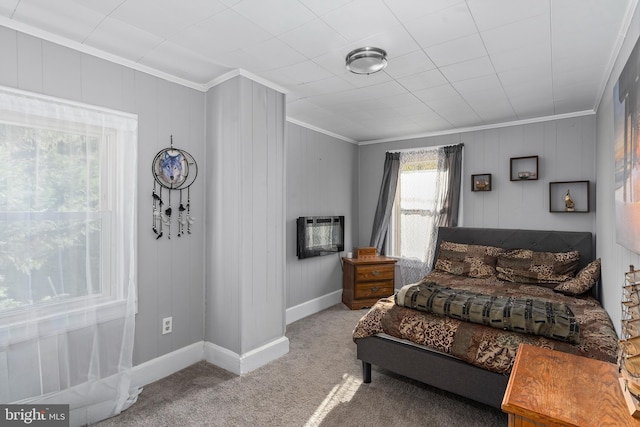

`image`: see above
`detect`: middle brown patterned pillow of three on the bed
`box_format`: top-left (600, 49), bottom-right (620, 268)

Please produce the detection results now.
top-left (496, 249), bottom-right (580, 288)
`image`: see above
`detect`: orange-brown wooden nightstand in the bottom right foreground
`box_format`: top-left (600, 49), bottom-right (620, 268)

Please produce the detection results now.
top-left (502, 344), bottom-right (640, 427)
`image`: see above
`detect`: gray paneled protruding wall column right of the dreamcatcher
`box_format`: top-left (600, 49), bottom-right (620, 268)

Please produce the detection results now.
top-left (205, 77), bottom-right (285, 355)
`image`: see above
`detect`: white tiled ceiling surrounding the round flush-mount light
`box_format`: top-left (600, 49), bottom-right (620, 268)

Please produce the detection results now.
top-left (0, 0), bottom-right (638, 141)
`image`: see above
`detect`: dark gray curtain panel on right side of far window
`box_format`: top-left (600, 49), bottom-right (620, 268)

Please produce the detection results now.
top-left (438, 144), bottom-right (464, 227)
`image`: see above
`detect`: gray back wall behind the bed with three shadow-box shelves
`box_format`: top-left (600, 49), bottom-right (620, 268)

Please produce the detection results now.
top-left (358, 115), bottom-right (596, 249)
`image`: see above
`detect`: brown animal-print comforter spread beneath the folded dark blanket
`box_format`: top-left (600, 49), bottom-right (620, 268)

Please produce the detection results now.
top-left (353, 270), bottom-right (618, 374)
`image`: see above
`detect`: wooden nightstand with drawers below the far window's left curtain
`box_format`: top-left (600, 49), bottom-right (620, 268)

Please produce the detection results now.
top-left (342, 256), bottom-right (396, 310)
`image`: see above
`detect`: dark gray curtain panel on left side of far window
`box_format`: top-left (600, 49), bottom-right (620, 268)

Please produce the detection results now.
top-left (369, 153), bottom-right (400, 255)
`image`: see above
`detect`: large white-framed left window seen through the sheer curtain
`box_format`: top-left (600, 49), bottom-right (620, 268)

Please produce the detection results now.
top-left (0, 89), bottom-right (137, 332)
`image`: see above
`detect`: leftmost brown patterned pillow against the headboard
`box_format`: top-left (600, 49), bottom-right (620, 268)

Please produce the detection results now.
top-left (435, 240), bottom-right (504, 278)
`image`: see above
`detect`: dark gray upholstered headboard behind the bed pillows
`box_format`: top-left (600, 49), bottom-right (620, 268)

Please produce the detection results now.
top-left (434, 227), bottom-right (600, 300)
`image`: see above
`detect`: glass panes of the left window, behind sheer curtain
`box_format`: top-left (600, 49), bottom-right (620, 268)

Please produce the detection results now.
top-left (0, 124), bottom-right (103, 311)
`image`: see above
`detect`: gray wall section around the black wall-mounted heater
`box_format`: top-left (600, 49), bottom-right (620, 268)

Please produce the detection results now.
top-left (286, 123), bottom-right (358, 308)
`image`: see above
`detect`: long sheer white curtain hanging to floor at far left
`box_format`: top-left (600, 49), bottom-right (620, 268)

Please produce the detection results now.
top-left (0, 88), bottom-right (139, 425)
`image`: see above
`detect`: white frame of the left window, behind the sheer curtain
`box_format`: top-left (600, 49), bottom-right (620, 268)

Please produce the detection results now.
top-left (0, 88), bottom-right (137, 334)
